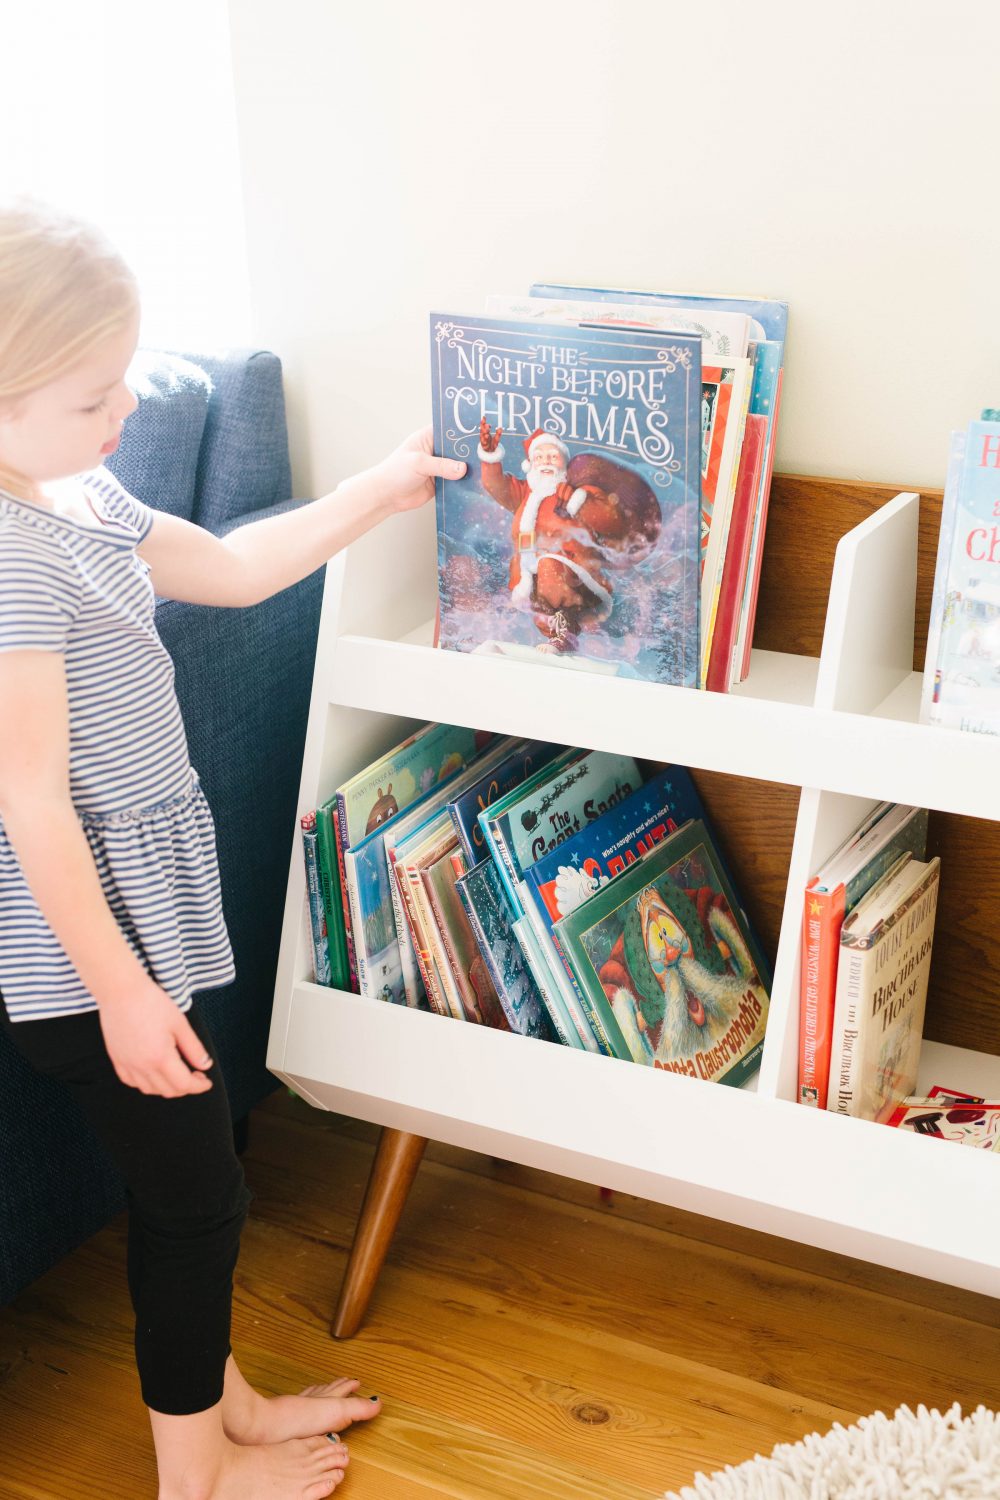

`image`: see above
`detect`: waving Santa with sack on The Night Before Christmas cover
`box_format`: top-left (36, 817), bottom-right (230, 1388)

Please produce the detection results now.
top-left (478, 420), bottom-right (660, 651)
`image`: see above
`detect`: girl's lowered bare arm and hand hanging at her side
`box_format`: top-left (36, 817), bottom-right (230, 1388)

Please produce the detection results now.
top-left (0, 651), bottom-right (211, 1098)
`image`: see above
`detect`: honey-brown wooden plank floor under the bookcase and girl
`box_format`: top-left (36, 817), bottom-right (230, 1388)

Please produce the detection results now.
top-left (0, 1091), bottom-right (1000, 1500)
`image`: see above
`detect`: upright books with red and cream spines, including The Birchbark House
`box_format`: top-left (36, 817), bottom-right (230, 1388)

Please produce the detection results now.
top-left (798, 803), bottom-right (940, 1122)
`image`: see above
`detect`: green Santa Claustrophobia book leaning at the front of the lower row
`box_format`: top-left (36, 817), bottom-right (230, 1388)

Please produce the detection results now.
top-left (553, 821), bottom-right (768, 1085)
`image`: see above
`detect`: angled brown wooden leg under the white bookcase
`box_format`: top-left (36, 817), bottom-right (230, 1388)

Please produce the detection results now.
top-left (333, 1127), bottom-right (427, 1338)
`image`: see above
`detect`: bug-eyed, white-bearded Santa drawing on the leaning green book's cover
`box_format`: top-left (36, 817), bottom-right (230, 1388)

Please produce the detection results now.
top-left (598, 881), bottom-right (766, 1064)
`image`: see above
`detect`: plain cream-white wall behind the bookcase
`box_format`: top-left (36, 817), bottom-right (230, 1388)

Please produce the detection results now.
top-left (231, 0), bottom-right (1000, 492)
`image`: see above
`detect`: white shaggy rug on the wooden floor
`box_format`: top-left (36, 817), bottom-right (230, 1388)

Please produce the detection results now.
top-left (666, 1406), bottom-right (1000, 1500)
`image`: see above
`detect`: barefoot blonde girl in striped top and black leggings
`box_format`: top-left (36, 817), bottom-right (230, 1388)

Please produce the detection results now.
top-left (0, 204), bottom-right (463, 1500)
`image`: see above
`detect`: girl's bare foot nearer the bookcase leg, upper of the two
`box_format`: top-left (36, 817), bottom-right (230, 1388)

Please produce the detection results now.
top-left (222, 1359), bottom-right (382, 1443)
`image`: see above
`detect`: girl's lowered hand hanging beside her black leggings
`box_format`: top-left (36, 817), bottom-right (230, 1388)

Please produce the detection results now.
top-left (100, 977), bottom-right (211, 1100)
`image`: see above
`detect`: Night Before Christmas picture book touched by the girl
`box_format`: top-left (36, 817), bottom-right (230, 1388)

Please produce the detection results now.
top-left (430, 314), bottom-right (702, 687)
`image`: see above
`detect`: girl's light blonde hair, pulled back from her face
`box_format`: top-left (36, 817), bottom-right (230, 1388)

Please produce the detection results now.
top-left (0, 198), bottom-right (139, 402)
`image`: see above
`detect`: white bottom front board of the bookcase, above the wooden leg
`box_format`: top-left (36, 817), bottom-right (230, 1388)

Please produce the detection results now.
top-left (268, 981), bottom-right (1000, 1296)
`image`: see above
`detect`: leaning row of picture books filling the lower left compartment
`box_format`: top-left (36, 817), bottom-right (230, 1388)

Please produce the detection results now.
top-left (303, 725), bottom-right (771, 1085)
